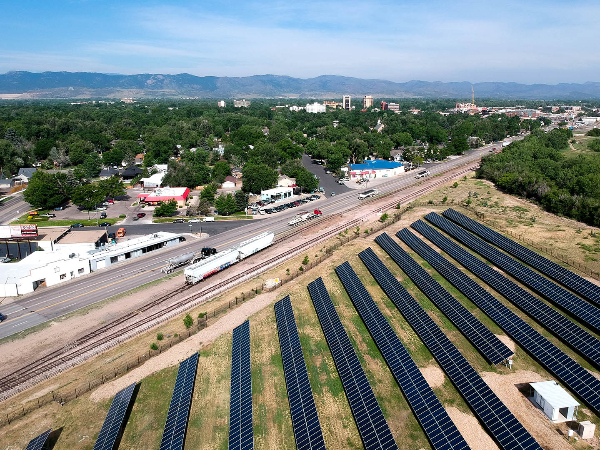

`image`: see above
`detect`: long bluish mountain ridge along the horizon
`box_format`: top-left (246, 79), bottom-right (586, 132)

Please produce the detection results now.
top-left (0, 72), bottom-right (600, 100)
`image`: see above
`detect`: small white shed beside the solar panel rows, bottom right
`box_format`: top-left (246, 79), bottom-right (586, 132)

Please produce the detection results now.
top-left (529, 381), bottom-right (579, 422)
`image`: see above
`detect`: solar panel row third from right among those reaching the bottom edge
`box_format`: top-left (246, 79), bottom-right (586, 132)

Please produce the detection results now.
top-left (308, 278), bottom-right (398, 450)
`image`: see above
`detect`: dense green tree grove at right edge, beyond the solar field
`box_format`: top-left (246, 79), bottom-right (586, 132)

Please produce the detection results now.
top-left (477, 129), bottom-right (600, 226)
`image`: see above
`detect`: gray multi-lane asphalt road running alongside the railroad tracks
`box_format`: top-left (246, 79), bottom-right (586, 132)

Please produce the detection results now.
top-left (0, 139), bottom-right (516, 339)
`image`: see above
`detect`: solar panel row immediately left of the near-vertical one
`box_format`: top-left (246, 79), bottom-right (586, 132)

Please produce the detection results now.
top-left (160, 352), bottom-right (198, 450)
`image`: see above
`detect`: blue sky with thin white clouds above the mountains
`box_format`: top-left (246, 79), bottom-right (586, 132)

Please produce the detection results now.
top-left (0, 0), bottom-right (600, 84)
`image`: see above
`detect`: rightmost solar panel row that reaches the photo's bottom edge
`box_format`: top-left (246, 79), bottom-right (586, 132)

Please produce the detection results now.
top-left (368, 233), bottom-right (541, 449)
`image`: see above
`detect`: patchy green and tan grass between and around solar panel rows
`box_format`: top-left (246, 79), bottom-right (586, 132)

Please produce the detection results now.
top-left (0, 173), bottom-right (600, 449)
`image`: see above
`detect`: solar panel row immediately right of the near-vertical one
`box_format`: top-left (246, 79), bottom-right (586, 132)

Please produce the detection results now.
top-left (275, 295), bottom-right (325, 450)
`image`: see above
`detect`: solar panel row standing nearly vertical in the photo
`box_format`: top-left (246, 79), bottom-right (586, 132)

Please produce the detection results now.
top-left (229, 321), bottom-right (254, 450)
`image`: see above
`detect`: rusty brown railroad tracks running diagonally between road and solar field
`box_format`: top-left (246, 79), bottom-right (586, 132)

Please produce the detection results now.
top-left (0, 161), bottom-right (474, 401)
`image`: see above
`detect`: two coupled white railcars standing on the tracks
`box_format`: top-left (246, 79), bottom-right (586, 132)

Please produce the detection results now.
top-left (184, 231), bottom-right (275, 284)
